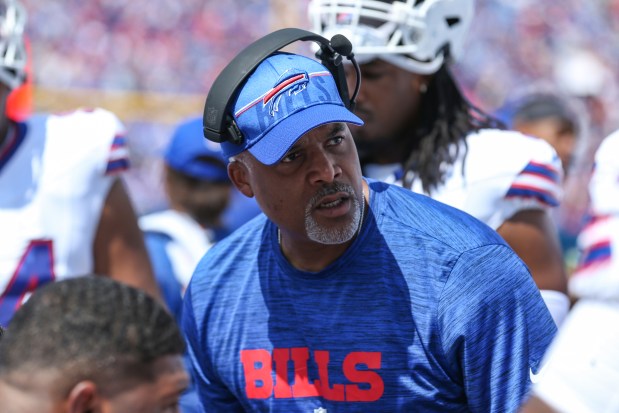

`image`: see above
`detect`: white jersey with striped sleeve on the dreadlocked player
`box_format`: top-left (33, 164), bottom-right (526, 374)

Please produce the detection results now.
top-left (400, 129), bottom-right (563, 230)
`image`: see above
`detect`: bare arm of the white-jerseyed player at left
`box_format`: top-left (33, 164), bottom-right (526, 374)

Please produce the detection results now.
top-left (93, 178), bottom-right (162, 301)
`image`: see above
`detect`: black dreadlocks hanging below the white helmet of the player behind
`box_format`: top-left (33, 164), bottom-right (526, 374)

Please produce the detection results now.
top-left (403, 65), bottom-right (505, 194)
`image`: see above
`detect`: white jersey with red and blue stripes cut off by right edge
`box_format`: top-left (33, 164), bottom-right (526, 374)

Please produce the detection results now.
top-left (569, 132), bottom-right (619, 300)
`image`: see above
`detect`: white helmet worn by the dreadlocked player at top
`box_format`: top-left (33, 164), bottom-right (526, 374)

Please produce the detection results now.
top-left (308, 0), bottom-right (474, 74)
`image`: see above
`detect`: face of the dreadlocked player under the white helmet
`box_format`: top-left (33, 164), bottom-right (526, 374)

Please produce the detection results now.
top-left (346, 60), bottom-right (426, 162)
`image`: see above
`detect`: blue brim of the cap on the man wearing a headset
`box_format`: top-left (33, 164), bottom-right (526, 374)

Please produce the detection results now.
top-left (249, 103), bottom-right (363, 165)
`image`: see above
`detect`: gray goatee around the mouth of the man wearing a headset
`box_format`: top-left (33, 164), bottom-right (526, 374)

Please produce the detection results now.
top-left (305, 182), bottom-right (364, 245)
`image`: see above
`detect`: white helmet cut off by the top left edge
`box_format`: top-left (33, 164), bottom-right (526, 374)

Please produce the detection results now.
top-left (0, 0), bottom-right (26, 89)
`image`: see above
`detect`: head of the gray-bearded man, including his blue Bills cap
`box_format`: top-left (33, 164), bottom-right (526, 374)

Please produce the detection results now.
top-left (222, 53), bottom-right (365, 269)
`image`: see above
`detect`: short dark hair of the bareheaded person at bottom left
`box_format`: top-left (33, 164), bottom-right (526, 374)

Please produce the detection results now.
top-left (0, 276), bottom-right (185, 393)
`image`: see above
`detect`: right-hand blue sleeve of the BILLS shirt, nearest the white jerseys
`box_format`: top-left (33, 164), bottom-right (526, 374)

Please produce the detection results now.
top-left (439, 245), bottom-right (556, 412)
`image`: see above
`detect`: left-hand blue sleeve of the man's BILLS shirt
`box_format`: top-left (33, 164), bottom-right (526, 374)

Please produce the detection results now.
top-left (181, 278), bottom-right (245, 413)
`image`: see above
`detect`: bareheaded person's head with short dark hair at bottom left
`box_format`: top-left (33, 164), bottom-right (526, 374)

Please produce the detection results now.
top-left (0, 276), bottom-right (189, 413)
